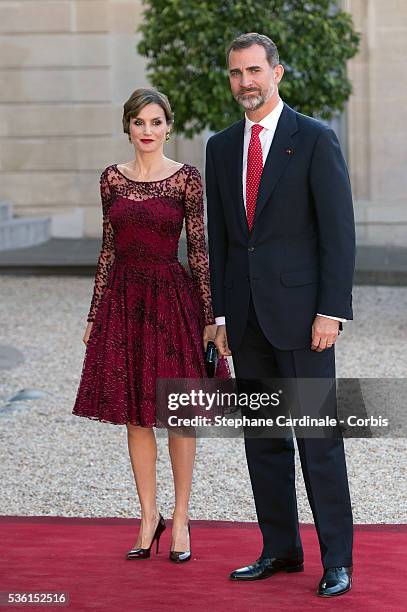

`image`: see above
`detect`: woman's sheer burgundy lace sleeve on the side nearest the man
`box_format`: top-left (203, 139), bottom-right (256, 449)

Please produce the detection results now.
top-left (184, 167), bottom-right (215, 325)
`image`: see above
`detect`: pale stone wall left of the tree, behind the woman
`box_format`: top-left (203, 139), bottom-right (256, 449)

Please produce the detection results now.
top-left (0, 0), bottom-right (203, 237)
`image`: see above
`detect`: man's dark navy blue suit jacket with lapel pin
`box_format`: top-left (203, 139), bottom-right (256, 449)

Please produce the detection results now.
top-left (206, 104), bottom-right (355, 351)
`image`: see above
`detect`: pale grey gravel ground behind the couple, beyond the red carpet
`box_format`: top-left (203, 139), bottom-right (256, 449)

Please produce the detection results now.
top-left (0, 276), bottom-right (407, 523)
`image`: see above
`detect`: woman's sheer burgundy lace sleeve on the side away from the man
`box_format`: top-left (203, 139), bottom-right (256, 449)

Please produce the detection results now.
top-left (87, 169), bottom-right (115, 321)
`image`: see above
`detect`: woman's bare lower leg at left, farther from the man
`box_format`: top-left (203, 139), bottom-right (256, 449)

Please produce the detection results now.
top-left (127, 423), bottom-right (159, 548)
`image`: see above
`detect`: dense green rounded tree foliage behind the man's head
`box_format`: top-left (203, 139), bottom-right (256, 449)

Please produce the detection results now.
top-left (138, 0), bottom-right (360, 137)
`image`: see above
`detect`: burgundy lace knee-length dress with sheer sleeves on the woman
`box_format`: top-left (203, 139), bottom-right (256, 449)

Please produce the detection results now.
top-left (73, 164), bottom-right (230, 427)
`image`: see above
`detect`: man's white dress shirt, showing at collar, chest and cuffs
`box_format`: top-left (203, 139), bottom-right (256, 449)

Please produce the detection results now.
top-left (215, 98), bottom-right (347, 325)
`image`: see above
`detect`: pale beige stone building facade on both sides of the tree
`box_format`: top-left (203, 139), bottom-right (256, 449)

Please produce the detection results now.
top-left (0, 0), bottom-right (407, 244)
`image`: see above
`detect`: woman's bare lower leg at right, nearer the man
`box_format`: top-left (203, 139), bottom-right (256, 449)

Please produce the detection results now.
top-left (168, 432), bottom-right (196, 552)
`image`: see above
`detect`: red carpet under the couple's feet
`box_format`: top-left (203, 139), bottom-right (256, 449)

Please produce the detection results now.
top-left (0, 516), bottom-right (407, 612)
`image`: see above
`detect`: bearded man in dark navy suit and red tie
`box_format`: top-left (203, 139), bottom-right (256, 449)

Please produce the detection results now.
top-left (206, 33), bottom-right (355, 596)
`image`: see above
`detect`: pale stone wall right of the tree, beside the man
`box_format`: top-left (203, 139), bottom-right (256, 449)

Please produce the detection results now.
top-left (344, 0), bottom-right (407, 246)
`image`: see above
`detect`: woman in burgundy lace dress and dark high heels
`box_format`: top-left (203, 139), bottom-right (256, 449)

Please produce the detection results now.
top-left (73, 88), bottom-right (229, 562)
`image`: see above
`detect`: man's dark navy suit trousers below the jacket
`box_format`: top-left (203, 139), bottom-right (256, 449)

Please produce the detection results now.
top-left (233, 299), bottom-right (353, 568)
